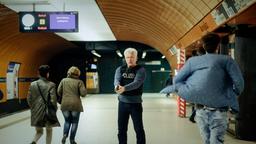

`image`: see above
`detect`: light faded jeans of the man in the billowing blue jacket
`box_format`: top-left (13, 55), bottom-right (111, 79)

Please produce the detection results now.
top-left (196, 109), bottom-right (228, 144)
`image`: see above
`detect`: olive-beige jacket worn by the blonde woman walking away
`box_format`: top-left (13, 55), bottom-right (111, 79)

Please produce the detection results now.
top-left (57, 77), bottom-right (86, 112)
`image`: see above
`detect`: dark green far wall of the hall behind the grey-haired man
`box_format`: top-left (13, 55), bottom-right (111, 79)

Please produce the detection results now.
top-left (82, 41), bottom-right (170, 93)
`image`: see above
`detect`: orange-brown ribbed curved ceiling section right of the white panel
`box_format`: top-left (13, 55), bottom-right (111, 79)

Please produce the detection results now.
top-left (97, 0), bottom-right (222, 53)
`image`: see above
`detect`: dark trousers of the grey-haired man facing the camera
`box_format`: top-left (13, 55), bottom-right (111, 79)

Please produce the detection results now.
top-left (118, 101), bottom-right (146, 144)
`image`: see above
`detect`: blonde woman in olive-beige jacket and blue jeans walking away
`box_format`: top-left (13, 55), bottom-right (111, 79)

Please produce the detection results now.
top-left (57, 66), bottom-right (86, 144)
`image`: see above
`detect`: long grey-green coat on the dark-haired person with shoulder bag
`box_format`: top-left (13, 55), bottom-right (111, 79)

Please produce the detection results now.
top-left (27, 77), bottom-right (60, 127)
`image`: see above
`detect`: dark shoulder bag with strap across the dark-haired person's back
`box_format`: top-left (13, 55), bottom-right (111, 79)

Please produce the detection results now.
top-left (37, 83), bottom-right (58, 124)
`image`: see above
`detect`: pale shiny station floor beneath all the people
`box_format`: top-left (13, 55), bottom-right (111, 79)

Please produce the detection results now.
top-left (0, 94), bottom-right (256, 144)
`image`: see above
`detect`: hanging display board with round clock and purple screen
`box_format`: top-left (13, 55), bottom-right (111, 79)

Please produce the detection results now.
top-left (19, 11), bottom-right (78, 32)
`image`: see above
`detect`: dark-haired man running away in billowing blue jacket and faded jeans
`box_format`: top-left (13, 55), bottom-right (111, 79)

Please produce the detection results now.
top-left (161, 33), bottom-right (244, 144)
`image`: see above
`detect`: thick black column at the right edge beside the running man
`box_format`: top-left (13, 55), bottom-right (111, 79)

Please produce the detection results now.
top-left (234, 27), bottom-right (256, 140)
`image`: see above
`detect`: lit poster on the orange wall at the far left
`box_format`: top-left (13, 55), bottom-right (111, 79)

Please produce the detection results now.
top-left (6, 62), bottom-right (20, 99)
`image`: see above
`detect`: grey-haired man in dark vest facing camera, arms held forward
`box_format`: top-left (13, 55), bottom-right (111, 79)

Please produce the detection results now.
top-left (114, 48), bottom-right (146, 144)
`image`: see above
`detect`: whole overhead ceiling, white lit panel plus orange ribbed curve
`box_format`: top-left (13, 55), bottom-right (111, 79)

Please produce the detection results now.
top-left (0, 0), bottom-right (222, 67)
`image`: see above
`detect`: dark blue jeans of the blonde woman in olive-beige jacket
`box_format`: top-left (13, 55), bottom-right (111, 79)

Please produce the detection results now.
top-left (62, 111), bottom-right (80, 140)
